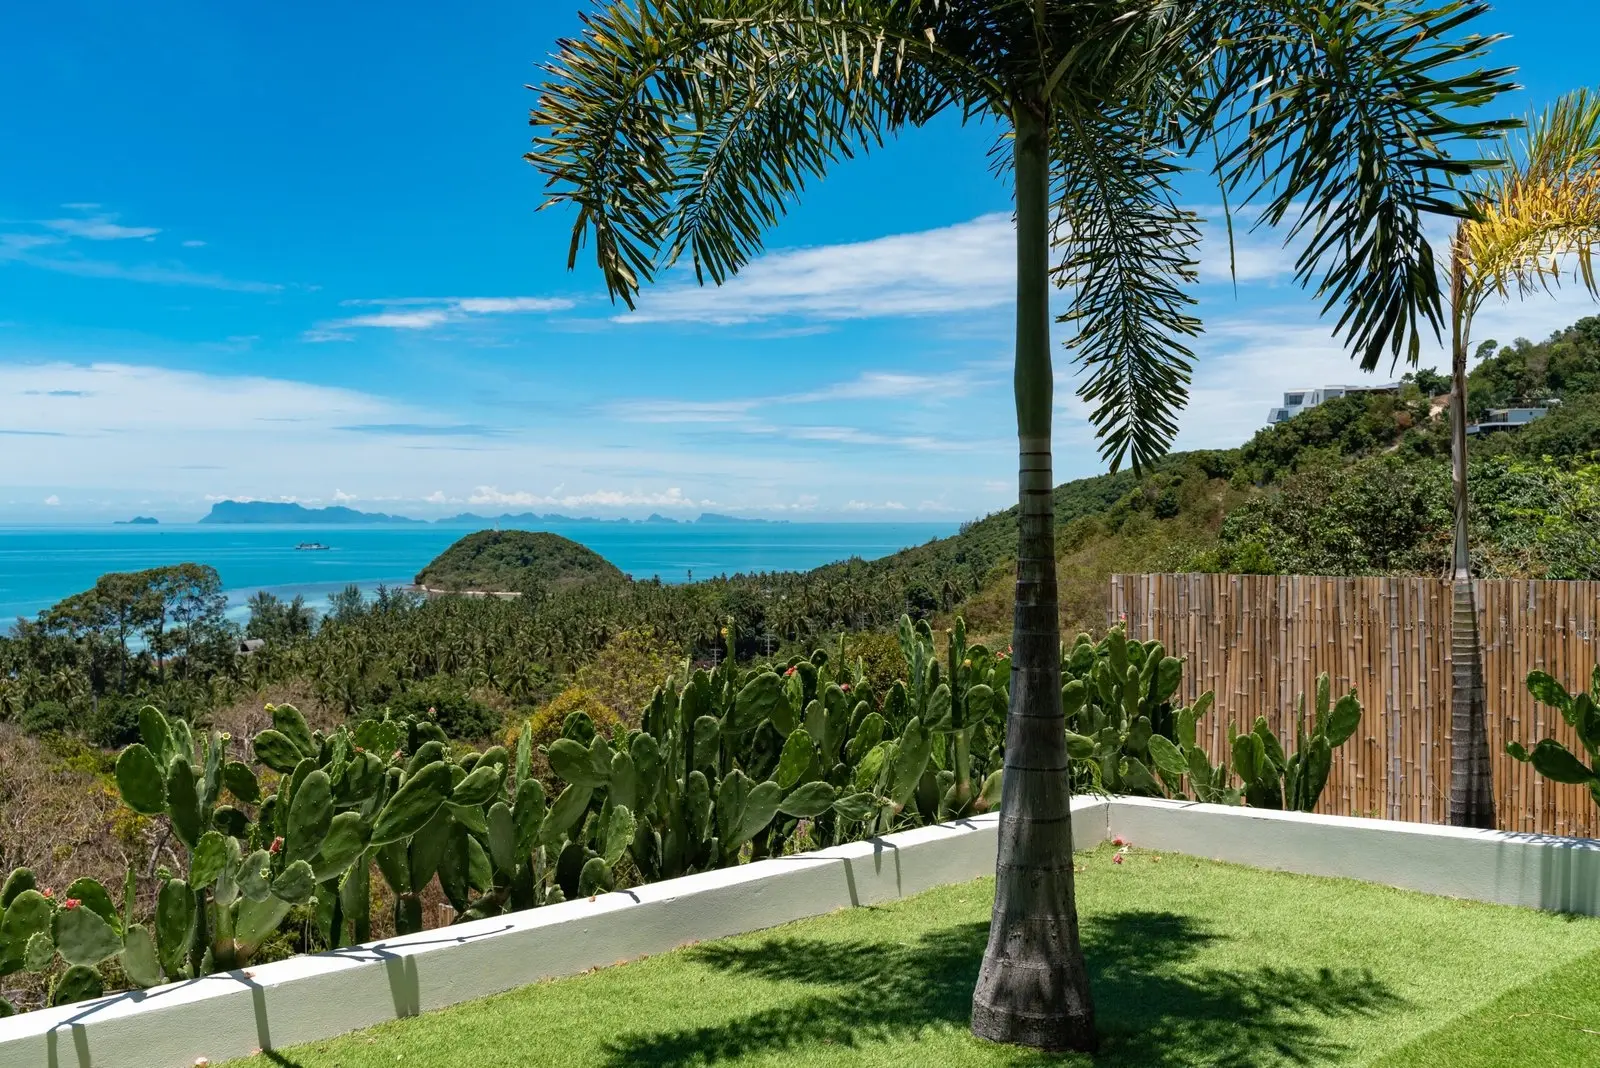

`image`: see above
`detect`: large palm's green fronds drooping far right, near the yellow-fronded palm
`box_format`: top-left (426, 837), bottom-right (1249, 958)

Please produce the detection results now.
top-left (1202, 0), bottom-right (1514, 371)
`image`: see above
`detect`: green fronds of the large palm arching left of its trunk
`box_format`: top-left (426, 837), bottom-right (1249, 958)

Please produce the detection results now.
top-left (525, 0), bottom-right (976, 304)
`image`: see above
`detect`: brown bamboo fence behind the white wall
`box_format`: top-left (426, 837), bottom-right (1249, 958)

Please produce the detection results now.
top-left (1109, 574), bottom-right (1600, 838)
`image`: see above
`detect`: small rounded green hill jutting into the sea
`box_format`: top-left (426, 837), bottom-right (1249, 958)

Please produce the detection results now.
top-left (416, 531), bottom-right (624, 592)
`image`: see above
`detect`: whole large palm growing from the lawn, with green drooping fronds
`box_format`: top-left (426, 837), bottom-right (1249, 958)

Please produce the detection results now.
top-left (528, 0), bottom-right (1507, 1049)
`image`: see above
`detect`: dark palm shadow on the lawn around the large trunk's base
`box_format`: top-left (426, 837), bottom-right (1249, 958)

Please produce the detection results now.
top-left (606, 911), bottom-right (1405, 1068)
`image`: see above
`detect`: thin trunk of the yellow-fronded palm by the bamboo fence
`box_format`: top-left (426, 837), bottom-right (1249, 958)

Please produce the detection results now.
top-left (1450, 241), bottom-right (1494, 828)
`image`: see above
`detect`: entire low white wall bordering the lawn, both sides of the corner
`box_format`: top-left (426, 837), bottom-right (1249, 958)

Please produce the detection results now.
top-left (12, 798), bottom-right (1600, 1068)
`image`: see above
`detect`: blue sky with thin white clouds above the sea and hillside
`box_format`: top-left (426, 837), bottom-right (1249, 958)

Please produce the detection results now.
top-left (0, 0), bottom-right (1600, 521)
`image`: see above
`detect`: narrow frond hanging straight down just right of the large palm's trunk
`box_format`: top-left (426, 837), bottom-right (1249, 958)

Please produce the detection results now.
top-left (1053, 109), bottom-right (1200, 470)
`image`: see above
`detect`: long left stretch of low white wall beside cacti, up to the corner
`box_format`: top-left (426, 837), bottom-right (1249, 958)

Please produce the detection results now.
top-left (0, 798), bottom-right (1107, 1068)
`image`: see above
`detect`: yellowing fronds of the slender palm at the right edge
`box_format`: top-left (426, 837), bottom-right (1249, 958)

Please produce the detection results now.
top-left (1453, 90), bottom-right (1600, 308)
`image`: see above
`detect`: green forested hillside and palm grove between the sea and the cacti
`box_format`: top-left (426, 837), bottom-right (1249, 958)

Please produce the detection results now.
top-left (0, 318), bottom-right (1600, 745)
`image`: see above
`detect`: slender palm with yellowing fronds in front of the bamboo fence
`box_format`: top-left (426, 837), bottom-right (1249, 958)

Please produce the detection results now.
top-left (1450, 90), bottom-right (1600, 828)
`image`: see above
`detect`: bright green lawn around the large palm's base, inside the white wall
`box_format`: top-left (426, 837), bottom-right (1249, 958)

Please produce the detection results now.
top-left (222, 847), bottom-right (1600, 1068)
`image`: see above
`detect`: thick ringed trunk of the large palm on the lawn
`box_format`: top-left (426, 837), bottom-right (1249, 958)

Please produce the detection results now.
top-left (973, 102), bottom-right (1096, 1050)
